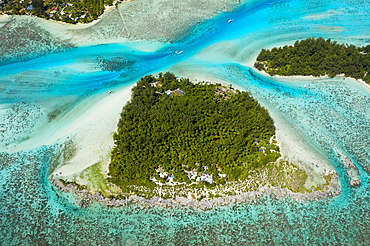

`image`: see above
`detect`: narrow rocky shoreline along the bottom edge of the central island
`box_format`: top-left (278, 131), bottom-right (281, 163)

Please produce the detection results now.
top-left (50, 175), bottom-right (340, 210)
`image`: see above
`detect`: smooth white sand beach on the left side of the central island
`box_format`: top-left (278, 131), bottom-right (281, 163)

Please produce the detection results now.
top-left (50, 83), bottom-right (131, 179)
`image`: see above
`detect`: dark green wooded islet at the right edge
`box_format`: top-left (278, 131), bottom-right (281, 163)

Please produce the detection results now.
top-left (254, 38), bottom-right (370, 83)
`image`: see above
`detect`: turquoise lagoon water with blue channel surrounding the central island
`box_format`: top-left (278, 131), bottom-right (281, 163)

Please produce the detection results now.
top-left (0, 0), bottom-right (370, 245)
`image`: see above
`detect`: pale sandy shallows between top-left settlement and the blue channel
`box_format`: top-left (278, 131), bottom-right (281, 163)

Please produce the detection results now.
top-left (0, 0), bottom-right (239, 47)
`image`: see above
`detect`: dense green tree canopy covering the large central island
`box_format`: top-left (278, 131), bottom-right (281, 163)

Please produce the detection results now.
top-left (108, 73), bottom-right (280, 187)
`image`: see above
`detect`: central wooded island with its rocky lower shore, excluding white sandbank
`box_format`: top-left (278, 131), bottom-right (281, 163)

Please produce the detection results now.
top-left (50, 72), bottom-right (340, 209)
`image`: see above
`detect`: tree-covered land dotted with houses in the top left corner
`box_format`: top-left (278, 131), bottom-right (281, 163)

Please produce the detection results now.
top-left (0, 0), bottom-right (121, 23)
